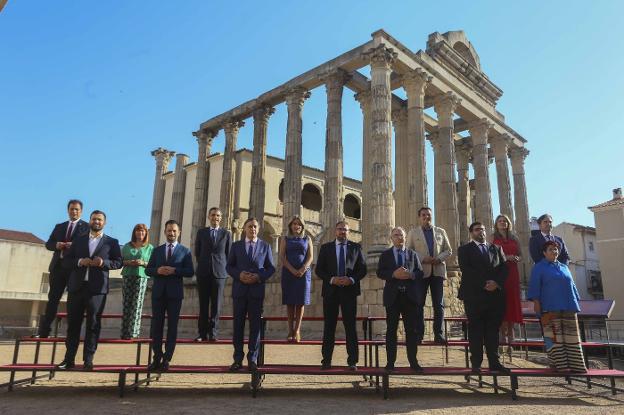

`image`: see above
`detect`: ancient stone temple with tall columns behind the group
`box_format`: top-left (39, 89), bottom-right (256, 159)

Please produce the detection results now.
top-left (151, 30), bottom-right (529, 336)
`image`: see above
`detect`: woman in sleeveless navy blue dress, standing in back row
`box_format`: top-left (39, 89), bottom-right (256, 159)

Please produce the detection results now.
top-left (279, 216), bottom-right (314, 342)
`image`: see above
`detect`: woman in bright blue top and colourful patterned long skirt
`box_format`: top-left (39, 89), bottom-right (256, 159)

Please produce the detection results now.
top-left (528, 241), bottom-right (587, 372)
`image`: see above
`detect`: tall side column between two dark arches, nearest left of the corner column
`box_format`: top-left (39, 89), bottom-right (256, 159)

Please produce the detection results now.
top-left (323, 70), bottom-right (348, 242)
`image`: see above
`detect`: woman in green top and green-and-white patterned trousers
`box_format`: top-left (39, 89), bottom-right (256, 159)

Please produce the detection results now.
top-left (121, 223), bottom-right (154, 340)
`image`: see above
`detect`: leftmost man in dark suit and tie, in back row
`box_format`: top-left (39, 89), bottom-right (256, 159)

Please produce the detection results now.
top-left (33, 199), bottom-right (89, 338)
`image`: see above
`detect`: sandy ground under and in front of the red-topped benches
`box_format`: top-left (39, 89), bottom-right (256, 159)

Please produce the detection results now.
top-left (0, 343), bottom-right (624, 415)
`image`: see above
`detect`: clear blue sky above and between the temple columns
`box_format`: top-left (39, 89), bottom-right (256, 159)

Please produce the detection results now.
top-left (0, 0), bottom-right (624, 242)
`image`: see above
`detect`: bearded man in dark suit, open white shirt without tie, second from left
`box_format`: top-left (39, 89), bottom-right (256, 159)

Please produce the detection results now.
top-left (58, 210), bottom-right (123, 370)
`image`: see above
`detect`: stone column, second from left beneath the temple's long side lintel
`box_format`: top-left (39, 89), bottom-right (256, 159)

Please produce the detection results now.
top-left (219, 120), bottom-right (245, 229)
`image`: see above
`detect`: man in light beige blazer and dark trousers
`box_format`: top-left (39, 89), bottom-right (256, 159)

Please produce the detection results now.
top-left (407, 207), bottom-right (453, 344)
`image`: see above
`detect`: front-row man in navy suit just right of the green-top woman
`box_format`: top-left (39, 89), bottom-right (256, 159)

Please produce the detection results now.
top-left (145, 220), bottom-right (194, 372)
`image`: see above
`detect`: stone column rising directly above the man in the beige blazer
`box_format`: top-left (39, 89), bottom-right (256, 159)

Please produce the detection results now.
top-left (397, 68), bottom-right (432, 227)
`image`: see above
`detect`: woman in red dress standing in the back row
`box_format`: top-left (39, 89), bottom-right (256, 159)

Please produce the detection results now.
top-left (492, 215), bottom-right (522, 343)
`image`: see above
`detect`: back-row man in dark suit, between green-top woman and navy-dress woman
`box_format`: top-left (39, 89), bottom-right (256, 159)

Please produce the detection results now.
top-left (195, 207), bottom-right (232, 341)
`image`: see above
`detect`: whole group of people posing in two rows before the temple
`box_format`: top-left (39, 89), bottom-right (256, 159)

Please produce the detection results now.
top-left (37, 200), bottom-right (582, 373)
